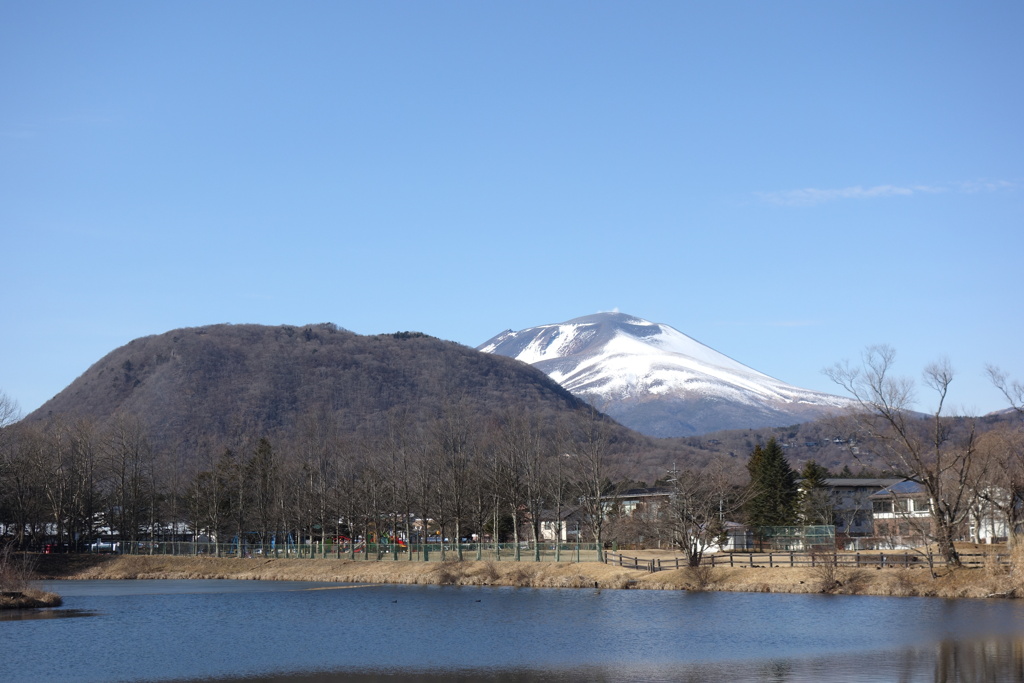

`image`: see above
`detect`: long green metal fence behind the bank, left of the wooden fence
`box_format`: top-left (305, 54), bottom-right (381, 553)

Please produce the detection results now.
top-left (115, 541), bottom-right (598, 562)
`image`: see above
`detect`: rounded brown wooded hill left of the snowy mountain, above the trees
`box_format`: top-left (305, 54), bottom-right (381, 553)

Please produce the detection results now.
top-left (26, 324), bottom-right (645, 462)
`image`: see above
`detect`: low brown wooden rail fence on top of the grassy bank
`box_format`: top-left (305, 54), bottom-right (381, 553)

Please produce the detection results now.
top-left (604, 551), bottom-right (1010, 571)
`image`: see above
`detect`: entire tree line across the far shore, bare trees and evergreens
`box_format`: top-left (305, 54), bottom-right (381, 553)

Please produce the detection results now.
top-left (0, 347), bottom-right (1024, 565)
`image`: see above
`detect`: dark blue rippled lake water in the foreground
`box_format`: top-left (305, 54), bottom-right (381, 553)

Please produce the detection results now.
top-left (0, 581), bottom-right (1024, 683)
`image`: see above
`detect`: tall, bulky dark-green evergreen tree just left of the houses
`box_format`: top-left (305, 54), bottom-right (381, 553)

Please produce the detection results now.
top-left (746, 438), bottom-right (800, 528)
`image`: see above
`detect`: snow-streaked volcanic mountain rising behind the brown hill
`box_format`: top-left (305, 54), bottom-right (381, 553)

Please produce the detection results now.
top-left (477, 312), bottom-right (849, 436)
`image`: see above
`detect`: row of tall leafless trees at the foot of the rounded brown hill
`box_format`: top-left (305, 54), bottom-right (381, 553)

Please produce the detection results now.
top-left (0, 403), bottom-right (663, 565)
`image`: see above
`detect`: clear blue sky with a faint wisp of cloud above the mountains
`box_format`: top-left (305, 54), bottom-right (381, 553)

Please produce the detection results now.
top-left (0, 1), bottom-right (1024, 414)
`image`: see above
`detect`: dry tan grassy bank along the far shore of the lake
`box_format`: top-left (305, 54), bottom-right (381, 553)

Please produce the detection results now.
top-left (37, 555), bottom-right (1024, 598)
